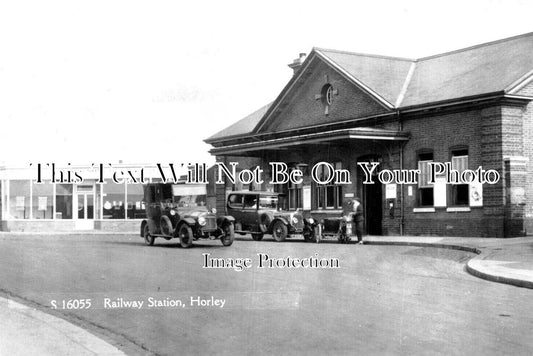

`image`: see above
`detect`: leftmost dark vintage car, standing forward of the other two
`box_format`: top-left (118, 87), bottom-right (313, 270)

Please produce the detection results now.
top-left (141, 183), bottom-right (235, 247)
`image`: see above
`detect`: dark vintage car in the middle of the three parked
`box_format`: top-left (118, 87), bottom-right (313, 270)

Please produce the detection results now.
top-left (227, 191), bottom-right (314, 241)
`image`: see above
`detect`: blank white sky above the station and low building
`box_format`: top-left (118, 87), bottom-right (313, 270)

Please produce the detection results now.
top-left (0, 0), bottom-right (533, 167)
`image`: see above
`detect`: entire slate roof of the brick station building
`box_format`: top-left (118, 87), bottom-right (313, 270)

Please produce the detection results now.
top-left (206, 32), bottom-right (533, 142)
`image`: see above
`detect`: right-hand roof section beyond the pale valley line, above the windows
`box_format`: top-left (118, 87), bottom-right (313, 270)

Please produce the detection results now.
top-left (401, 33), bottom-right (533, 107)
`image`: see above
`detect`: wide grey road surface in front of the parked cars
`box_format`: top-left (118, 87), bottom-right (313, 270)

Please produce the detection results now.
top-left (0, 235), bottom-right (533, 355)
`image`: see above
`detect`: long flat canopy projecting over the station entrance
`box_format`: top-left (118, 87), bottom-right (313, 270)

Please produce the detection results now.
top-left (209, 127), bottom-right (409, 156)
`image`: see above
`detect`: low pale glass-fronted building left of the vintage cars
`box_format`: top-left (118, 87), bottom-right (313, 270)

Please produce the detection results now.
top-left (0, 165), bottom-right (160, 231)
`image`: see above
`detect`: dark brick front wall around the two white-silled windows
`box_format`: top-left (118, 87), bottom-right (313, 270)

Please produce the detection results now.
top-left (404, 107), bottom-right (504, 237)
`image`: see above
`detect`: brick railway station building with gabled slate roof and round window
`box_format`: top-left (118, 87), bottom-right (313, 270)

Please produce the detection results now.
top-left (205, 33), bottom-right (533, 237)
